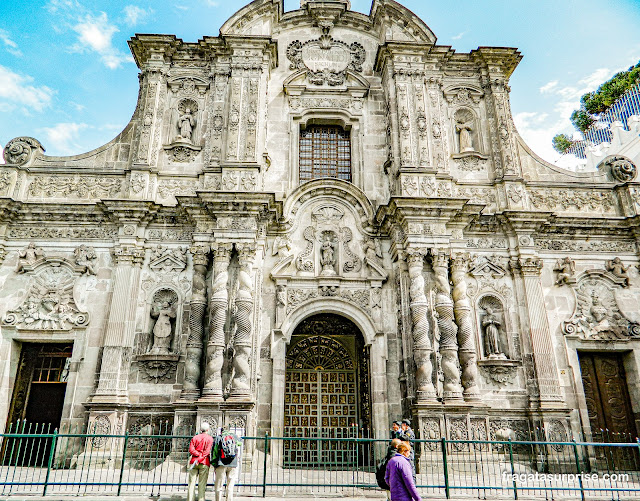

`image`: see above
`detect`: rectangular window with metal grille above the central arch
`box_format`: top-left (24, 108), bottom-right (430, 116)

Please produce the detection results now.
top-left (300, 125), bottom-right (351, 181)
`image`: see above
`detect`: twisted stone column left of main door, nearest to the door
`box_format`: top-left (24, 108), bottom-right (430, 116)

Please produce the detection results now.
top-left (230, 244), bottom-right (256, 400)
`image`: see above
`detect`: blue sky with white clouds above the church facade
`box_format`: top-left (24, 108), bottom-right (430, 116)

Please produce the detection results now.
top-left (0, 0), bottom-right (640, 161)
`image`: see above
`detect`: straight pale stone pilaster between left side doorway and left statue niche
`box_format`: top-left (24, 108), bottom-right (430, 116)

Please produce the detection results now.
top-left (92, 245), bottom-right (144, 403)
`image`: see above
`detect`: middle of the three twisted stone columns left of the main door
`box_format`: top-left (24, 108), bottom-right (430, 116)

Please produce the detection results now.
top-left (202, 243), bottom-right (232, 401)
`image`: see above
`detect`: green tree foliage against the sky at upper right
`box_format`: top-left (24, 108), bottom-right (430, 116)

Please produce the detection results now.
top-left (553, 62), bottom-right (640, 146)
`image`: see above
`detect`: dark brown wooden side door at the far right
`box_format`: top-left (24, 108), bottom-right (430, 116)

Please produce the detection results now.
top-left (579, 352), bottom-right (637, 442)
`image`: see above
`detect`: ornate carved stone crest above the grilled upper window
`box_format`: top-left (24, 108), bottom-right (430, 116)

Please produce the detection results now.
top-left (287, 33), bottom-right (366, 86)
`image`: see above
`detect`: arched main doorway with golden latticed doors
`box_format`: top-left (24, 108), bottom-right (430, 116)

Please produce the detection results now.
top-left (284, 314), bottom-right (371, 465)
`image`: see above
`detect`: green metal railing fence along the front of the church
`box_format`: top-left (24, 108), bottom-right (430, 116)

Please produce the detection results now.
top-left (0, 423), bottom-right (640, 499)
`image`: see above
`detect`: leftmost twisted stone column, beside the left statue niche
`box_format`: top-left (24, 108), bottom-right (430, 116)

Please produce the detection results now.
top-left (180, 244), bottom-right (209, 400)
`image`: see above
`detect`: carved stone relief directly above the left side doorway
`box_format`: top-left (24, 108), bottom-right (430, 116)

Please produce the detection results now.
top-left (2, 258), bottom-right (89, 330)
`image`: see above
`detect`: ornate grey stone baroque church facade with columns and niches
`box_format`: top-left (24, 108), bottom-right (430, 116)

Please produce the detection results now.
top-left (0, 0), bottom-right (640, 446)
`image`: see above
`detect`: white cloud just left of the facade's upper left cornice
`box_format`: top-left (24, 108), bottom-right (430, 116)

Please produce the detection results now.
top-left (73, 12), bottom-right (131, 70)
